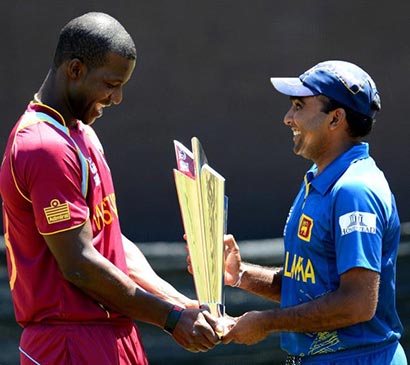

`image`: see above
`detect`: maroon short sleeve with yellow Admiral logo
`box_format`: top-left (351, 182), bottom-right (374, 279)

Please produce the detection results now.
top-left (13, 123), bottom-right (89, 234)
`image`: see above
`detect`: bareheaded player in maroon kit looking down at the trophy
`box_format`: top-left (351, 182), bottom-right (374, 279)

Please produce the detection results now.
top-left (0, 9), bottom-right (218, 365)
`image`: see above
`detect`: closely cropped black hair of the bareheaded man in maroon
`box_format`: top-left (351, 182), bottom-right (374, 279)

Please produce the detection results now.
top-left (53, 12), bottom-right (137, 69)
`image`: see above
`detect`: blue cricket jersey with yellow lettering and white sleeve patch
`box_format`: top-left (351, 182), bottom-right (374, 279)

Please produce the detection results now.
top-left (281, 143), bottom-right (402, 359)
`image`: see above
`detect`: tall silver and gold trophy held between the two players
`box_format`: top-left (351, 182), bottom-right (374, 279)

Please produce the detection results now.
top-left (174, 137), bottom-right (228, 330)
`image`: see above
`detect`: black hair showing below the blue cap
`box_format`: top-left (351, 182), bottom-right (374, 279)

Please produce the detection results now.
top-left (320, 95), bottom-right (378, 138)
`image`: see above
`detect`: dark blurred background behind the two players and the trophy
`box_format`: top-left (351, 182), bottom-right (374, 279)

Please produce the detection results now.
top-left (0, 0), bottom-right (410, 365)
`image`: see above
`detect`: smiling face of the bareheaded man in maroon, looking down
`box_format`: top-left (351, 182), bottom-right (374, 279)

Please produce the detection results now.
top-left (67, 53), bottom-right (135, 125)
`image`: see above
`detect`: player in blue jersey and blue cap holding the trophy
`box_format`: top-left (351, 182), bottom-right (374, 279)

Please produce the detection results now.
top-left (219, 61), bottom-right (407, 365)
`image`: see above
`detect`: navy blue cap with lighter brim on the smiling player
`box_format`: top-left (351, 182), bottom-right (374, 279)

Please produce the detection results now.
top-left (270, 61), bottom-right (381, 118)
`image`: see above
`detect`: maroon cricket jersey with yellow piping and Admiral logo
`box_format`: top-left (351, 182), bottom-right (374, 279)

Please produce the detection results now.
top-left (0, 103), bottom-right (127, 327)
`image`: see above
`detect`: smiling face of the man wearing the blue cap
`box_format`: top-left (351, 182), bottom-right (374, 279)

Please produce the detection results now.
top-left (283, 96), bottom-right (332, 163)
